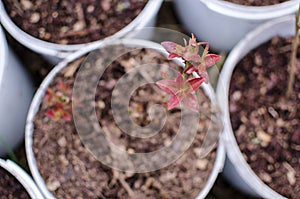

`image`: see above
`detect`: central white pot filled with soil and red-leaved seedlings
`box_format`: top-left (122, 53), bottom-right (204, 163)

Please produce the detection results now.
top-left (26, 35), bottom-right (224, 198)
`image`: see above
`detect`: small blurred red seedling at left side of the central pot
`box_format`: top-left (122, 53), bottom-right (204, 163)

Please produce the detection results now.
top-left (45, 81), bottom-right (72, 121)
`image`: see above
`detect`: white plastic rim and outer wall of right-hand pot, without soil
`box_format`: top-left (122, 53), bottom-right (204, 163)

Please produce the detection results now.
top-left (217, 16), bottom-right (295, 198)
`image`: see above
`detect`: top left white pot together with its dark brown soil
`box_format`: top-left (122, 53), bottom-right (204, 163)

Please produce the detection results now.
top-left (0, 0), bottom-right (162, 63)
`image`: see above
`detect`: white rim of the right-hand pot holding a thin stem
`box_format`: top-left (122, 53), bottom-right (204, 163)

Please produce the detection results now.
top-left (216, 16), bottom-right (295, 198)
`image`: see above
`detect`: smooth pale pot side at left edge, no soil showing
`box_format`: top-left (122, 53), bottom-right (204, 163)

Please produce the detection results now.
top-left (0, 26), bottom-right (33, 156)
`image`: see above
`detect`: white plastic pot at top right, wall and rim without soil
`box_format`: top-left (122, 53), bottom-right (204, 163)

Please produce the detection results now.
top-left (174, 0), bottom-right (300, 51)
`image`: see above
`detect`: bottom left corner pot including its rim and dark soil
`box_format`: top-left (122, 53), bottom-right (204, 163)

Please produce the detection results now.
top-left (0, 159), bottom-right (43, 199)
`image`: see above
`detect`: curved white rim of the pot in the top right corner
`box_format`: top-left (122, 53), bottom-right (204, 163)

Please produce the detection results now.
top-left (198, 0), bottom-right (300, 21)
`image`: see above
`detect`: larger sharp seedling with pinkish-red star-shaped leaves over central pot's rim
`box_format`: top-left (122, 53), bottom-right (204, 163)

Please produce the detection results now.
top-left (156, 34), bottom-right (220, 112)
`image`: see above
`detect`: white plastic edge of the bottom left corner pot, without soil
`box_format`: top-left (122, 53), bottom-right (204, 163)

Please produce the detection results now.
top-left (0, 159), bottom-right (44, 199)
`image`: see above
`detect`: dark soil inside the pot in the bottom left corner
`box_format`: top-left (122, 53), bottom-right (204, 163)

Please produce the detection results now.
top-left (0, 167), bottom-right (30, 199)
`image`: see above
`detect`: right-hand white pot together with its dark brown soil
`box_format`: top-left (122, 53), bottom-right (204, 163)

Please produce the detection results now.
top-left (217, 13), bottom-right (300, 198)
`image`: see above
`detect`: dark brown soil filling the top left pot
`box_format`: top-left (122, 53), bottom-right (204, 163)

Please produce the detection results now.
top-left (3, 0), bottom-right (147, 44)
